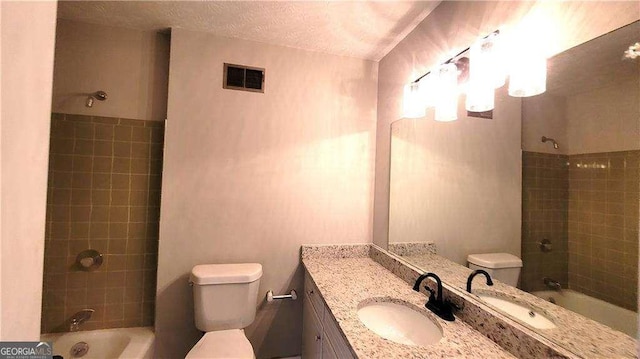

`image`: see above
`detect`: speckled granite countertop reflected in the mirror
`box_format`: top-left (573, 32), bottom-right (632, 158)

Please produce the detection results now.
top-left (402, 253), bottom-right (637, 358)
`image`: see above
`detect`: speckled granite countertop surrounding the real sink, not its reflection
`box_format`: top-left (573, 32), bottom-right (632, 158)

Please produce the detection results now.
top-left (302, 256), bottom-right (514, 359)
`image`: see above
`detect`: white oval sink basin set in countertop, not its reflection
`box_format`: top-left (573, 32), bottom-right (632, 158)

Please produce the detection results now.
top-left (358, 302), bottom-right (442, 346)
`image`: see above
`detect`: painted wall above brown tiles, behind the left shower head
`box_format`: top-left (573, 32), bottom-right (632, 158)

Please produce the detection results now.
top-left (53, 20), bottom-right (169, 121)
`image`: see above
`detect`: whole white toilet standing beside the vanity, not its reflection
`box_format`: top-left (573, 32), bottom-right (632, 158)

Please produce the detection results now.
top-left (186, 263), bottom-right (262, 359)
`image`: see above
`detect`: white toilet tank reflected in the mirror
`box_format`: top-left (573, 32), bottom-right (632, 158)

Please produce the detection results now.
top-left (467, 253), bottom-right (522, 287)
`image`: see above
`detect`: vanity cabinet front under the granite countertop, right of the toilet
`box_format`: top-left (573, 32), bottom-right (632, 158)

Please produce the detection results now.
top-left (302, 274), bottom-right (354, 359)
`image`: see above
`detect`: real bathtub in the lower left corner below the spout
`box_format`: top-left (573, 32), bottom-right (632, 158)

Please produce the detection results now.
top-left (40, 327), bottom-right (155, 359)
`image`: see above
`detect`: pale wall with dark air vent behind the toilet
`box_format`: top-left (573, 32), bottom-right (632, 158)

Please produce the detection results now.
top-left (156, 29), bottom-right (377, 358)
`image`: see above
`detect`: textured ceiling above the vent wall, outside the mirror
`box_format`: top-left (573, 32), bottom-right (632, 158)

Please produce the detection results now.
top-left (58, 1), bottom-right (440, 61)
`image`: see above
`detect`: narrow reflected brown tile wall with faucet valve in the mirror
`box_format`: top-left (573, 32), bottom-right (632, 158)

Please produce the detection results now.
top-left (520, 152), bottom-right (569, 291)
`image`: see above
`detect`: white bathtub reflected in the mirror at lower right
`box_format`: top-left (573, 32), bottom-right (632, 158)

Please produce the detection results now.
top-left (531, 289), bottom-right (638, 338)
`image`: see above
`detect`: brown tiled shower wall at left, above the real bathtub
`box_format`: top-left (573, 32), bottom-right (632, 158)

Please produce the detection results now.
top-left (42, 114), bottom-right (164, 333)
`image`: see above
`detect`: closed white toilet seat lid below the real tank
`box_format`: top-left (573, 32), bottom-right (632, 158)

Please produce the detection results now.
top-left (185, 329), bottom-right (255, 359)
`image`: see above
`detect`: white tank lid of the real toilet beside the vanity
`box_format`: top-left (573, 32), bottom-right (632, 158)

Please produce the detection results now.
top-left (189, 263), bottom-right (262, 285)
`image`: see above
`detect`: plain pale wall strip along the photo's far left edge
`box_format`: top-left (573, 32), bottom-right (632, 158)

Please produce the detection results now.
top-left (0, 1), bottom-right (57, 341)
